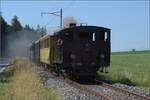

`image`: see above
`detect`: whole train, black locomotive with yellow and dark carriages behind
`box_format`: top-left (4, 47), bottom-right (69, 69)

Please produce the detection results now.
top-left (30, 23), bottom-right (111, 79)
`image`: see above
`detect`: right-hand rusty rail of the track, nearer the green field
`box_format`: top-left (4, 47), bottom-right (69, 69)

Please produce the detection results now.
top-left (96, 80), bottom-right (150, 100)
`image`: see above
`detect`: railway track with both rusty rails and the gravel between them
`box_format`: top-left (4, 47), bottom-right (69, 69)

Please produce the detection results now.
top-left (43, 67), bottom-right (150, 100)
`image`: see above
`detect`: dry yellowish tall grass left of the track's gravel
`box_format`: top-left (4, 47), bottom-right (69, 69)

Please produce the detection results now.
top-left (0, 59), bottom-right (59, 100)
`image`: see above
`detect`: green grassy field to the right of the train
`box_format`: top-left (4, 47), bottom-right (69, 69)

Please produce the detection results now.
top-left (98, 51), bottom-right (150, 88)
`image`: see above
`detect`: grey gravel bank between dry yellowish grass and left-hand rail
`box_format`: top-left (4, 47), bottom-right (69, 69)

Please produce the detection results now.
top-left (35, 68), bottom-right (100, 100)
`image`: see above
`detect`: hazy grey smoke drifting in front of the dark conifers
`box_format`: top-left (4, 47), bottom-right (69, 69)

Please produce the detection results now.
top-left (6, 30), bottom-right (38, 58)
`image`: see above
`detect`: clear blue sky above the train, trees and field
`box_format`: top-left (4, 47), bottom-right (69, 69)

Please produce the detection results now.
top-left (1, 1), bottom-right (150, 51)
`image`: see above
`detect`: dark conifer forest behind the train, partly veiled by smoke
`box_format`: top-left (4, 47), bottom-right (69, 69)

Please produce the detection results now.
top-left (0, 15), bottom-right (47, 57)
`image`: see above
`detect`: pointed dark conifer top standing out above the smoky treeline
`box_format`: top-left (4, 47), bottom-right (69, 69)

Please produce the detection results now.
top-left (11, 16), bottom-right (23, 31)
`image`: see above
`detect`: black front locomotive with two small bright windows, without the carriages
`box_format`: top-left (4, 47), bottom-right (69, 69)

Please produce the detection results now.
top-left (58, 26), bottom-right (110, 78)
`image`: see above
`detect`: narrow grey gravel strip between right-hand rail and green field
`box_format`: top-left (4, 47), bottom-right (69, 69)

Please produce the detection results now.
top-left (113, 83), bottom-right (150, 98)
